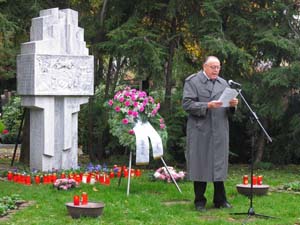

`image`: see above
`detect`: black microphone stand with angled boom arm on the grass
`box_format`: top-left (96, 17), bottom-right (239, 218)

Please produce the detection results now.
top-left (231, 88), bottom-right (276, 224)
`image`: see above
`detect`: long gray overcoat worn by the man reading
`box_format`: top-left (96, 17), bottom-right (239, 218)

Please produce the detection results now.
top-left (183, 71), bottom-right (235, 182)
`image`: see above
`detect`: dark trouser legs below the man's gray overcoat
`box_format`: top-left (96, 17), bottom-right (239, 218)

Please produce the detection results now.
top-left (194, 181), bottom-right (226, 204)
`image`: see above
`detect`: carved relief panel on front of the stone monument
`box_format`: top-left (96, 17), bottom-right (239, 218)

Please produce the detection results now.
top-left (36, 55), bottom-right (93, 95)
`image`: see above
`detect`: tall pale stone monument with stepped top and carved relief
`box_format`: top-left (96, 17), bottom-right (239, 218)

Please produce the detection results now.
top-left (17, 8), bottom-right (94, 171)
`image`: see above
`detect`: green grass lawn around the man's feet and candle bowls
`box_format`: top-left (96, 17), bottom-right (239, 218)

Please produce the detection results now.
top-left (0, 162), bottom-right (300, 225)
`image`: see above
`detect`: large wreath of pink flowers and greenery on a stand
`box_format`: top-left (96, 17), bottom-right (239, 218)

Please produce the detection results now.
top-left (108, 86), bottom-right (168, 151)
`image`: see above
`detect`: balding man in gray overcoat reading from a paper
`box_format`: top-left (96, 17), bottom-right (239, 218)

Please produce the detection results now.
top-left (183, 56), bottom-right (238, 211)
